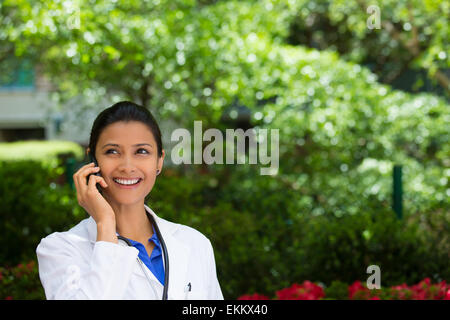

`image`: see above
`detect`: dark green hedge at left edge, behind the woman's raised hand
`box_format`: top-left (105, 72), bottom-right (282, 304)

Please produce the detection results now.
top-left (0, 160), bottom-right (85, 266)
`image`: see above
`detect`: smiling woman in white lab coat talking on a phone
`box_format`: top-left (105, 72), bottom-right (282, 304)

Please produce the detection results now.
top-left (36, 101), bottom-right (223, 300)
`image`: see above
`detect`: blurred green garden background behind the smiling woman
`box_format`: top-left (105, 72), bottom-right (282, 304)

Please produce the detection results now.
top-left (0, 0), bottom-right (450, 299)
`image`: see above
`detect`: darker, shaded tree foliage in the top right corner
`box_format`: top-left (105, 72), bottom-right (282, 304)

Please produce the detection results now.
top-left (289, 0), bottom-right (450, 97)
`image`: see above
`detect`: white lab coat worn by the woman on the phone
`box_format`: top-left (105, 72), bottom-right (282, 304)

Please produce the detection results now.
top-left (36, 205), bottom-right (223, 300)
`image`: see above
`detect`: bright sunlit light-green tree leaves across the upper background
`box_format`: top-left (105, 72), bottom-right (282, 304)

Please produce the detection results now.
top-left (0, 0), bottom-right (450, 218)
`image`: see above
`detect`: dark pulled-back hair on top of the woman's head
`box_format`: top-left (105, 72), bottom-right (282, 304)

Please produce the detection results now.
top-left (89, 101), bottom-right (162, 157)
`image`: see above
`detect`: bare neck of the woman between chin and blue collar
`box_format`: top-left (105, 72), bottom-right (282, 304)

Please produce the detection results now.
top-left (110, 201), bottom-right (153, 244)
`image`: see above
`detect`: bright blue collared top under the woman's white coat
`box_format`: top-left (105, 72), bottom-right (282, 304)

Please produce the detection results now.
top-left (117, 224), bottom-right (164, 285)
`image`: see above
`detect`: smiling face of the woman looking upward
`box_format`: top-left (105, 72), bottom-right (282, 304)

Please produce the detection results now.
top-left (89, 121), bottom-right (164, 205)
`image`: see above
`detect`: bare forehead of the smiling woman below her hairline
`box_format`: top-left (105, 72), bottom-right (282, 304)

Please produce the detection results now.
top-left (97, 121), bottom-right (155, 145)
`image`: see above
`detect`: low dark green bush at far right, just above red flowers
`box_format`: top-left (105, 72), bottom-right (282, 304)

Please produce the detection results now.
top-left (291, 208), bottom-right (450, 285)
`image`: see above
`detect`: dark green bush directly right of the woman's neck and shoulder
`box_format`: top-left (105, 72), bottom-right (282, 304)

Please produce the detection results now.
top-left (149, 171), bottom-right (306, 299)
